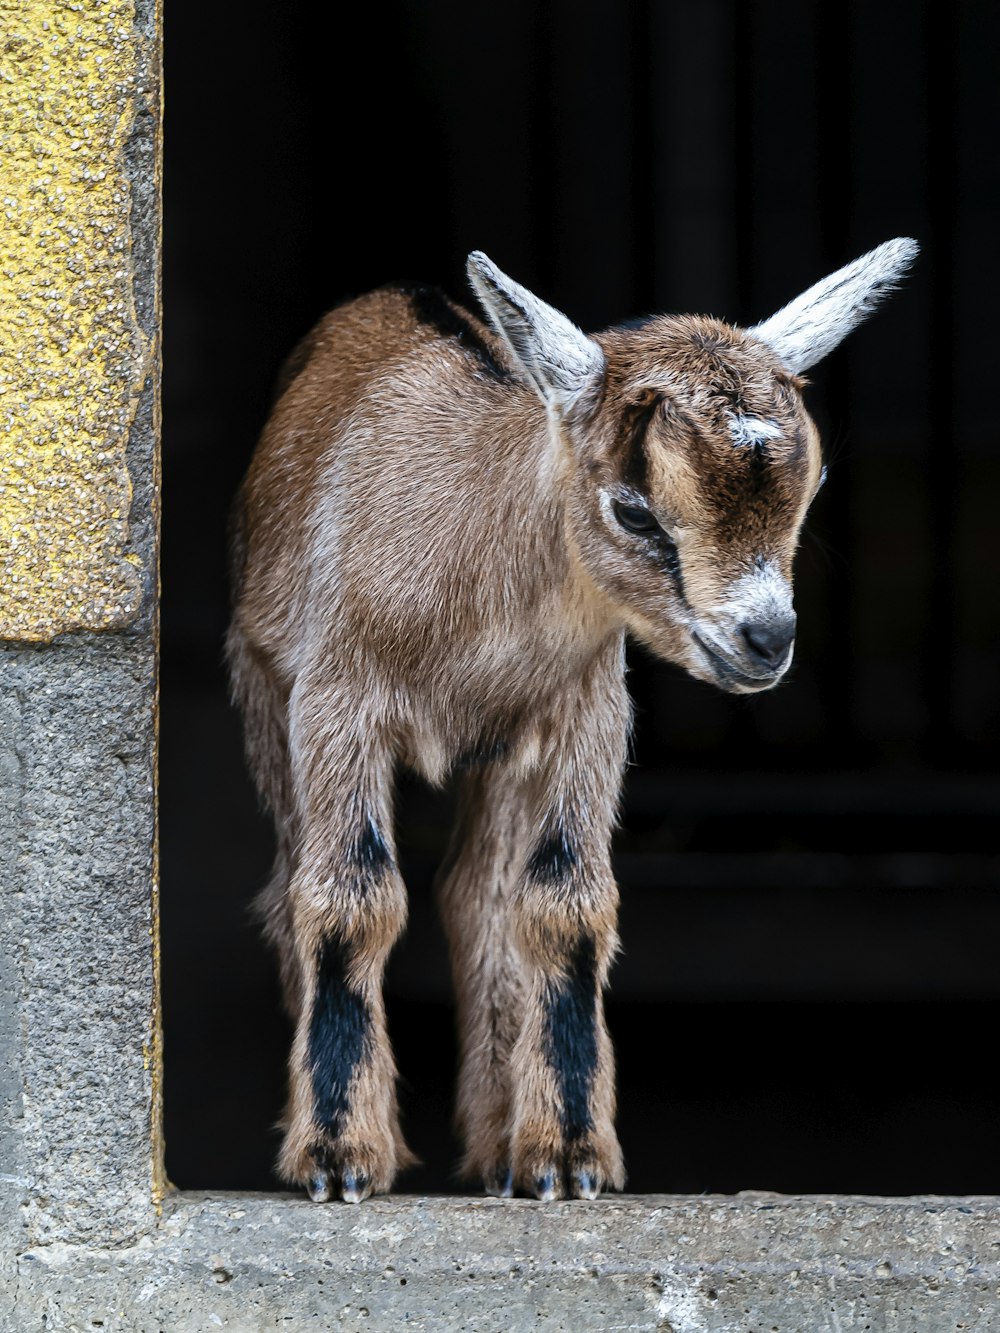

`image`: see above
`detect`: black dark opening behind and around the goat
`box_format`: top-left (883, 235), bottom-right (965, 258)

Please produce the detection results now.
top-left (161, 0), bottom-right (1000, 1193)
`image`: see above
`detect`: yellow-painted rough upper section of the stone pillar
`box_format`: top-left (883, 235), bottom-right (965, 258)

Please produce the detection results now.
top-left (0, 0), bottom-right (159, 643)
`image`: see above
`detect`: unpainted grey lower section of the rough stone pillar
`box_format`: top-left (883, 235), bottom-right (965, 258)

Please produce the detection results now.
top-left (0, 636), bottom-right (159, 1253)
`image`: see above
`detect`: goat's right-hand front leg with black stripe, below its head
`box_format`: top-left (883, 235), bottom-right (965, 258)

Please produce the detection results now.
top-left (511, 649), bottom-right (629, 1200)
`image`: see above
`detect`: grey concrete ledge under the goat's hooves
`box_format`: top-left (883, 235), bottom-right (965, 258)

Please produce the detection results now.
top-left (7, 1193), bottom-right (1000, 1333)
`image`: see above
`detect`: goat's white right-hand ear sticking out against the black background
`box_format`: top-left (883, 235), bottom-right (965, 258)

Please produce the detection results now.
top-left (747, 236), bottom-right (920, 375)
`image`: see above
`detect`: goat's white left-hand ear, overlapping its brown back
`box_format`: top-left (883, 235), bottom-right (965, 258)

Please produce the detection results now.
top-left (467, 251), bottom-right (604, 409)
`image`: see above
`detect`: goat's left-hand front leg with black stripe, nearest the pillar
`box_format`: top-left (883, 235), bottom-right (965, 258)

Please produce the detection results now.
top-left (279, 677), bottom-right (412, 1202)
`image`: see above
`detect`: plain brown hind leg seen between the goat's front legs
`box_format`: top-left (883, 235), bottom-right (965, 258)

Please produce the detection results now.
top-left (437, 764), bottom-right (525, 1196)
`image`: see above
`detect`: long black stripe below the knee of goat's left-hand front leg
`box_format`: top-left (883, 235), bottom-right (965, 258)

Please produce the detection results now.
top-left (309, 936), bottom-right (372, 1134)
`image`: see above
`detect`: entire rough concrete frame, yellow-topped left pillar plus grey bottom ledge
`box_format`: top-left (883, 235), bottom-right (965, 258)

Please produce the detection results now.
top-left (0, 0), bottom-right (1000, 1333)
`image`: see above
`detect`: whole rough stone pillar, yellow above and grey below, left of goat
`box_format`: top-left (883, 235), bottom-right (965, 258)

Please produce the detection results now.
top-left (0, 0), bottom-right (163, 1279)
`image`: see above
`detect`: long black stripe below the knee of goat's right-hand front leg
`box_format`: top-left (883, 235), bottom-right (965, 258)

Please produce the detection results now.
top-left (545, 934), bottom-right (597, 1142)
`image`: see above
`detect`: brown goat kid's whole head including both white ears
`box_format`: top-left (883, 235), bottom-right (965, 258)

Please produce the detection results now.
top-left (469, 239), bottom-right (917, 693)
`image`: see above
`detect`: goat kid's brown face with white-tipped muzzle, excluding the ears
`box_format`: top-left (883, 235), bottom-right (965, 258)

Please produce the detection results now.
top-left (565, 317), bottom-right (821, 693)
